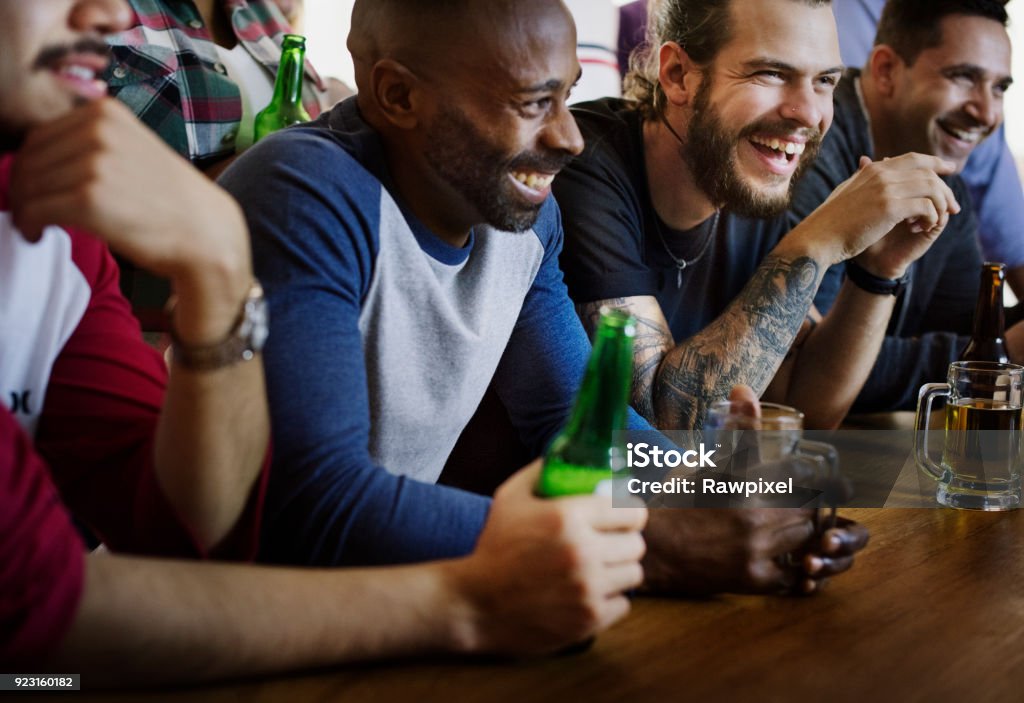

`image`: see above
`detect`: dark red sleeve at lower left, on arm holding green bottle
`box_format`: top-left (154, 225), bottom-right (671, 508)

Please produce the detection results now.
top-left (0, 404), bottom-right (85, 663)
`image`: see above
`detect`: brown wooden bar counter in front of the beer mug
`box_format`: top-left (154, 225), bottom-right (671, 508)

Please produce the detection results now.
top-left (76, 509), bottom-right (1024, 703)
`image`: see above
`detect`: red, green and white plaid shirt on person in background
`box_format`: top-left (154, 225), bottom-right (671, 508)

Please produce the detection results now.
top-left (104, 0), bottom-right (324, 168)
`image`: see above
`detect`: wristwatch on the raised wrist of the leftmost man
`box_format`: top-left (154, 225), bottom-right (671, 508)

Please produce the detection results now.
top-left (170, 280), bottom-right (269, 371)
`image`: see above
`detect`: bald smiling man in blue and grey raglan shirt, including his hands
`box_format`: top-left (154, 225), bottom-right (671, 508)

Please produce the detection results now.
top-left (221, 0), bottom-right (866, 592)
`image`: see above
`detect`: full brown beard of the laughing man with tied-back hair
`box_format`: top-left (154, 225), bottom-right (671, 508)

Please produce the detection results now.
top-left (680, 73), bottom-right (821, 219)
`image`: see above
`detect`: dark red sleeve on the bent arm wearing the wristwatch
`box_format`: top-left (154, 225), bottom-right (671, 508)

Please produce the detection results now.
top-left (36, 234), bottom-right (269, 560)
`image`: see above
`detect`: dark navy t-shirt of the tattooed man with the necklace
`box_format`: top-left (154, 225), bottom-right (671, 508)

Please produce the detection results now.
top-left (554, 98), bottom-right (788, 342)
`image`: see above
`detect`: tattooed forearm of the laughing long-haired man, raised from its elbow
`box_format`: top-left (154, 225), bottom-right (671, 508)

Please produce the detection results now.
top-left (648, 256), bottom-right (819, 429)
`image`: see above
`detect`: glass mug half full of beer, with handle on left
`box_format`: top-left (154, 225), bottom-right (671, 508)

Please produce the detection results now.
top-left (914, 361), bottom-right (1024, 511)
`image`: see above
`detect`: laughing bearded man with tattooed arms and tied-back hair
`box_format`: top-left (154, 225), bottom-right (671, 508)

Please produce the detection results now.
top-left (554, 0), bottom-right (959, 429)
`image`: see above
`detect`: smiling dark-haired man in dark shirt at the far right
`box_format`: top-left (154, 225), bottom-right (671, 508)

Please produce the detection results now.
top-left (792, 0), bottom-right (1024, 411)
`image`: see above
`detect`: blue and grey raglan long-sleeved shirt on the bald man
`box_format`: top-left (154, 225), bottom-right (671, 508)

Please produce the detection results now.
top-left (221, 99), bottom-right (646, 565)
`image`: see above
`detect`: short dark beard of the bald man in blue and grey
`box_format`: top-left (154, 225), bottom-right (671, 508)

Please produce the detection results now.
top-left (424, 106), bottom-right (571, 232)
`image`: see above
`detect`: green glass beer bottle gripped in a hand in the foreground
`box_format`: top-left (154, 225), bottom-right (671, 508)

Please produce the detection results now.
top-left (537, 307), bottom-right (636, 496)
